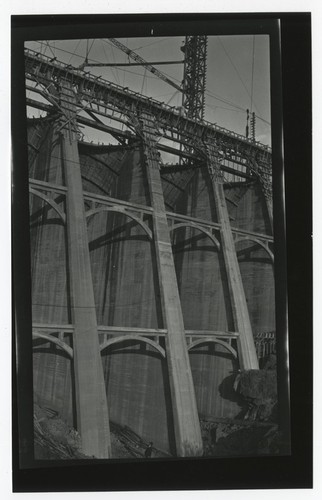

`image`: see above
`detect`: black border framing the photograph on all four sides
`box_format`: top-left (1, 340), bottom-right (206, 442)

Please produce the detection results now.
top-left (11, 13), bottom-right (313, 492)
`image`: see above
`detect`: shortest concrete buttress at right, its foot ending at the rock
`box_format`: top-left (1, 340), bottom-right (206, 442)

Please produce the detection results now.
top-left (207, 147), bottom-right (259, 370)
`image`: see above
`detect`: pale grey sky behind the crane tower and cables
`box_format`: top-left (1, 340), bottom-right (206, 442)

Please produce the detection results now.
top-left (26, 35), bottom-right (271, 145)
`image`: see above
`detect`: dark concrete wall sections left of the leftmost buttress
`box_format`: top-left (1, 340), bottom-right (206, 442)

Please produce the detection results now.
top-left (28, 120), bottom-right (74, 424)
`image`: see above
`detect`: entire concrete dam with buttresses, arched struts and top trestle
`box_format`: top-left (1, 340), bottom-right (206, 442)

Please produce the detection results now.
top-left (26, 46), bottom-right (275, 458)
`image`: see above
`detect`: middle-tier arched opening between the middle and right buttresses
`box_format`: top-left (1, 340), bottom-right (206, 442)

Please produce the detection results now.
top-left (173, 222), bottom-right (234, 331)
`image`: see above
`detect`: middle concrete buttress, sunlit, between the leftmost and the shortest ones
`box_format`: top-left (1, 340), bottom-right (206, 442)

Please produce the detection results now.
top-left (137, 113), bottom-right (203, 457)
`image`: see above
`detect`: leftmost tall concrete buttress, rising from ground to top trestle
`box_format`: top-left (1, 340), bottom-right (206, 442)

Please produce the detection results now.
top-left (61, 80), bottom-right (111, 458)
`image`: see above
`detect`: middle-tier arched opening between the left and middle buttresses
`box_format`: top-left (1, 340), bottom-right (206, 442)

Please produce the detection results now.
top-left (87, 207), bottom-right (162, 328)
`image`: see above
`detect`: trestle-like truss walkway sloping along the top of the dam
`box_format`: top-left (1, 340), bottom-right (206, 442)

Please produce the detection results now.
top-left (25, 50), bottom-right (272, 185)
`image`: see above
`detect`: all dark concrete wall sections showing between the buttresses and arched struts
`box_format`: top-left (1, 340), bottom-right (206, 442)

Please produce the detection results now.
top-left (29, 120), bottom-right (274, 450)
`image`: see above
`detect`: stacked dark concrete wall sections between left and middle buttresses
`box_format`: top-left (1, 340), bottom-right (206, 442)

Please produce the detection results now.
top-left (84, 144), bottom-right (171, 450)
